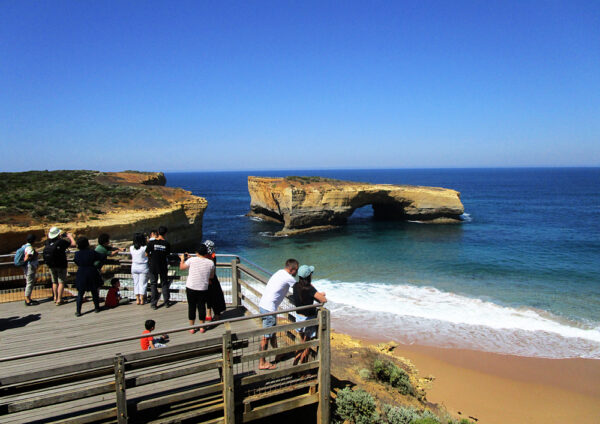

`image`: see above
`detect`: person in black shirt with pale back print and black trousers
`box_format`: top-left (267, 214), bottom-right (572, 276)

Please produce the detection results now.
top-left (146, 226), bottom-right (172, 309)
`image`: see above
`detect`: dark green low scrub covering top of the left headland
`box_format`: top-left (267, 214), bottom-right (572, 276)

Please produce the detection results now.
top-left (0, 171), bottom-right (142, 225)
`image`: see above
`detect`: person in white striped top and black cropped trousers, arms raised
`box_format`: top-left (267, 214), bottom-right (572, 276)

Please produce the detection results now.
top-left (179, 244), bottom-right (215, 334)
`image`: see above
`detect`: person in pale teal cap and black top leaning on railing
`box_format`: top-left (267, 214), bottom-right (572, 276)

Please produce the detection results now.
top-left (293, 265), bottom-right (327, 365)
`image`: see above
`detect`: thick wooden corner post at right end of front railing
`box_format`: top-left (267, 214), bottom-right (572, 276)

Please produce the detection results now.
top-left (317, 308), bottom-right (331, 424)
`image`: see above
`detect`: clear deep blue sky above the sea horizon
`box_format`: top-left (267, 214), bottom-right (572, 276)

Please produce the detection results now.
top-left (0, 0), bottom-right (600, 171)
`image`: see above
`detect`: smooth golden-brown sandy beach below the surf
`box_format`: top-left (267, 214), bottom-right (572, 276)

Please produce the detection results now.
top-left (333, 322), bottom-right (600, 424)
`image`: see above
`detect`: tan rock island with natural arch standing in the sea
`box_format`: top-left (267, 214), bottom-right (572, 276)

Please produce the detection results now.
top-left (248, 177), bottom-right (464, 234)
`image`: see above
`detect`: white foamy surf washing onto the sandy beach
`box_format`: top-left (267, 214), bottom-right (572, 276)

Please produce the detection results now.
top-left (314, 280), bottom-right (600, 358)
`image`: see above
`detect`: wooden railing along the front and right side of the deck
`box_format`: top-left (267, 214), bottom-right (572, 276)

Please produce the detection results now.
top-left (0, 255), bottom-right (330, 424)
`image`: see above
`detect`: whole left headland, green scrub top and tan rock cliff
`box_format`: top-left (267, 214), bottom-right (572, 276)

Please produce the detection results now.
top-left (0, 170), bottom-right (207, 253)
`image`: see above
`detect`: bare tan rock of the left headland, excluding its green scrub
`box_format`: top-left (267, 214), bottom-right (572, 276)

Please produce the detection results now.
top-left (0, 172), bottom-right (207, 253)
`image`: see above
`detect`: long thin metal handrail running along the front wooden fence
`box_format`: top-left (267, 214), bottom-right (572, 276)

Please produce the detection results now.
top-left (0, 303), bottom-right (324, 362)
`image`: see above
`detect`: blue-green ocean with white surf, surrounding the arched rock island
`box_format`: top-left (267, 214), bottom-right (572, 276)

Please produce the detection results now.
top-left (166, 168), bottom-right (600, 359)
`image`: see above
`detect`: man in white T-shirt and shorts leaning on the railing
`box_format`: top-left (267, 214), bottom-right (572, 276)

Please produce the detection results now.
top-left (258, 259), bottom-right (299, 370)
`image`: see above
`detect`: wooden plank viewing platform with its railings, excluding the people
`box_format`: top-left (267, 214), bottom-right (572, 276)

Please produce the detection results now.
top-left (0, 255), bottom-right (330, 423)
